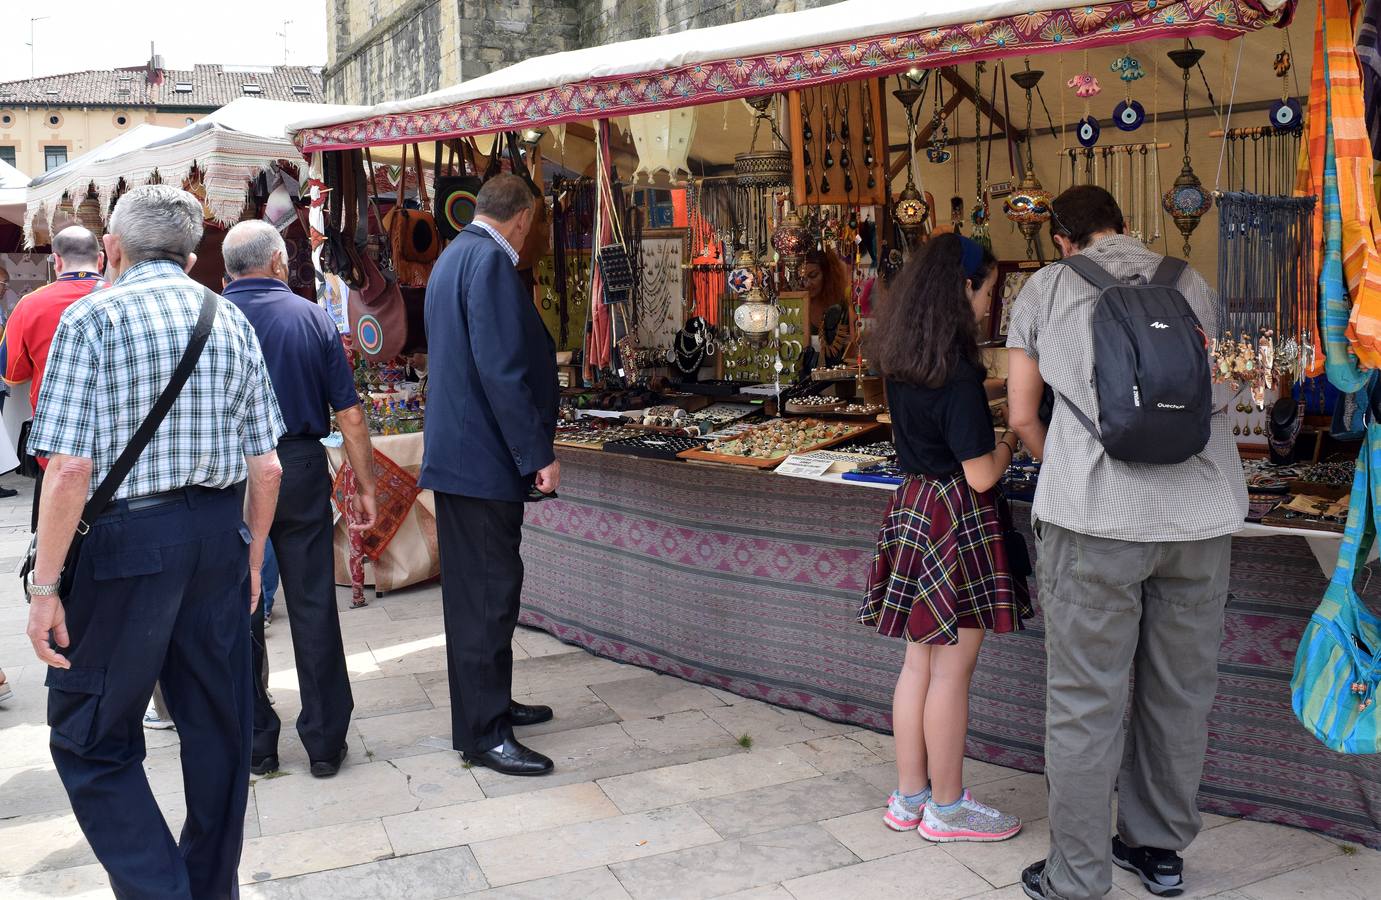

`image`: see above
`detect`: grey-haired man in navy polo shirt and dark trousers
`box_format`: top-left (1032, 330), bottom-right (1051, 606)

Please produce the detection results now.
top-left (221, 221), bottom-right (374, 779)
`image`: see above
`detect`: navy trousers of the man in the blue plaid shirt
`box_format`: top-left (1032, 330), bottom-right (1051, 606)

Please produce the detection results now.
top-left (47, 487), bottom-right (253, 900)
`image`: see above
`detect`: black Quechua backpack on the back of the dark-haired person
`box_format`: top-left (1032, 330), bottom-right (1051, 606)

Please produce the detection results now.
top-left (1061, 254), bottom-right (1213, 465)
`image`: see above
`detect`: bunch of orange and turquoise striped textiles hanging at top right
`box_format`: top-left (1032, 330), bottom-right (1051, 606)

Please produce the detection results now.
top-left (1301, 0), bottom-right (1381, 375)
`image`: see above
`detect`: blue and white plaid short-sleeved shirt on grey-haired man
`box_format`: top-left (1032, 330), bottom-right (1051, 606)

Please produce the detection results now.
top-left (29, 260), bottom-right (283, 498)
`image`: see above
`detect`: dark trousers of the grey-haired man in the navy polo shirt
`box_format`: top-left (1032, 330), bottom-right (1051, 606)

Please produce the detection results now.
top-left (254, 438), bottom-right (355, 759)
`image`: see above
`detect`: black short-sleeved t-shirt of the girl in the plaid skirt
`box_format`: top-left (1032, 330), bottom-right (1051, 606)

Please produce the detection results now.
top-left (887, 362), bottom-right (997, 478)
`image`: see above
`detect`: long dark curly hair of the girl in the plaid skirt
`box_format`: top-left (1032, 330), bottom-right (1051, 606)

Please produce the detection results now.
top-left (867, 233), bottom-right (997, 388)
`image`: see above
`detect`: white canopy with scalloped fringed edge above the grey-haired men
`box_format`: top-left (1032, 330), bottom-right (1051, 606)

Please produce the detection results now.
top-left (25, 97), bottom-right (366, 246)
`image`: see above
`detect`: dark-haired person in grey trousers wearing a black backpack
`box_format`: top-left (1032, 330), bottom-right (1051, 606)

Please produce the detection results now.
top-left (1007, 185), bottom-right (1247, 900)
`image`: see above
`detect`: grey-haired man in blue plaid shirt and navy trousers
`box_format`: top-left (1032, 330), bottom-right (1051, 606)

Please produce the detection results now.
top-left (28, 185), bottom-right (283, 900)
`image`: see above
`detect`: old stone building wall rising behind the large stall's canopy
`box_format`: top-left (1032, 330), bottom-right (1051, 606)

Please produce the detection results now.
top-left (322, 0), bottom-right (834, 104)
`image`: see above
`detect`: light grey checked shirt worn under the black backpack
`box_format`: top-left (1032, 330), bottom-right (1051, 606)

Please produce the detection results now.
top-left (1007, 235), bottom-right (1247, 542)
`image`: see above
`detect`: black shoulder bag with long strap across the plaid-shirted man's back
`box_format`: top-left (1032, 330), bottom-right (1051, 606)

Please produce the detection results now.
top-left (19, 287), bottom-right (221, 598)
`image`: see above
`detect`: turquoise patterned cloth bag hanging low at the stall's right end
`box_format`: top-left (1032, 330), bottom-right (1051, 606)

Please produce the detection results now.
top-left (1290, 424), bottom-right (1381, 754)
